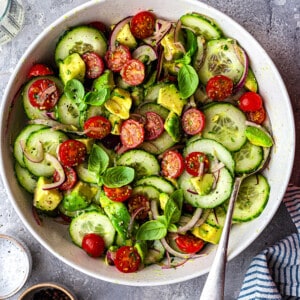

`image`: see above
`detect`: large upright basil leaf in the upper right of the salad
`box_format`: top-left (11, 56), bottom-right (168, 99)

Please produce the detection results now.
top-left (178, 65), bottom-right (199, 99)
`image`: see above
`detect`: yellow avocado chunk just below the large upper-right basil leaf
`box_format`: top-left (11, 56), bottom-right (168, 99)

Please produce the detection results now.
top-left (157, 84), bottom-right (186, 116)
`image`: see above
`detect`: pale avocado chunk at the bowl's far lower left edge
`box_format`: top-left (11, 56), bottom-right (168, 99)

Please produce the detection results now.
top-left (33, 176), bottom-right (63, 212)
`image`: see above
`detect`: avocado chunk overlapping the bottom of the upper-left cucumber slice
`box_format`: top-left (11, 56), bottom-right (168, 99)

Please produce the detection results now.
top-left (58, 53), bottom-right (86, 84)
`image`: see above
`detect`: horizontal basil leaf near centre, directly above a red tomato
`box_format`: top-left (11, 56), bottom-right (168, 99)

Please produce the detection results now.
top-left (102, 166), bottom-right (135, 188)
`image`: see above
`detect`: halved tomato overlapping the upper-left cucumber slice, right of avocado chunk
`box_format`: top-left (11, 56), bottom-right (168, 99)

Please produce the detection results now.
top-left (82, 52), bottom-right (105, 79)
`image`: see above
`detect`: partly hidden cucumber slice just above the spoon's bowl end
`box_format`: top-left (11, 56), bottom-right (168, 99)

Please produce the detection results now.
top-left (233, 142), bottom-right (264, 174)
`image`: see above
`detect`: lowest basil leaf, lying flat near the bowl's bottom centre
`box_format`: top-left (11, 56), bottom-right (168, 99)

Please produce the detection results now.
top-left (136, 220), bottom-right (167, 241)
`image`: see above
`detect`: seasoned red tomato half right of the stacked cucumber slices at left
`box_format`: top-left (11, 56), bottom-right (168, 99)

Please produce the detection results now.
top-left (58, 139), bottom-right (86, 167)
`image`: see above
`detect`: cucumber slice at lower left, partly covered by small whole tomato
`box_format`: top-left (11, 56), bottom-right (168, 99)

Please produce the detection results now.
top-left (69, 211), bottom-right (116, 248)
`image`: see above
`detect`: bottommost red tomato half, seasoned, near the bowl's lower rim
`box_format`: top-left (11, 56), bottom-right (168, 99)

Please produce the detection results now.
top-left (114, 246), bottom-right (141, 273)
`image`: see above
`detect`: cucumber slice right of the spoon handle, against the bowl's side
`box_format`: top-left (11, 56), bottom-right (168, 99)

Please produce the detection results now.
top-left (232, 174), bottom-right (270, 222)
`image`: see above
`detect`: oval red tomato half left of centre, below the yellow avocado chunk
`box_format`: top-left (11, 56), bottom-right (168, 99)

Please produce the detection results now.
top-left (83, 116), bottom-right (111, 139)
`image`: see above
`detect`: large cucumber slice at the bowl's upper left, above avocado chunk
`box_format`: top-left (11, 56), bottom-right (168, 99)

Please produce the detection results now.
top-left (55, 25), bottom-right (107, 63)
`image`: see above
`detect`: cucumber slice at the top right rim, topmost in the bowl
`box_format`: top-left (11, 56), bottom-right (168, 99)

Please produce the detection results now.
top-left (180, 13), bottom-right (222, 40)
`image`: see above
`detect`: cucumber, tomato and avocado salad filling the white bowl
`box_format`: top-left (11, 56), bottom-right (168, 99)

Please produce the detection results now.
top-left (13, 11), bottom-right (273, 273)
